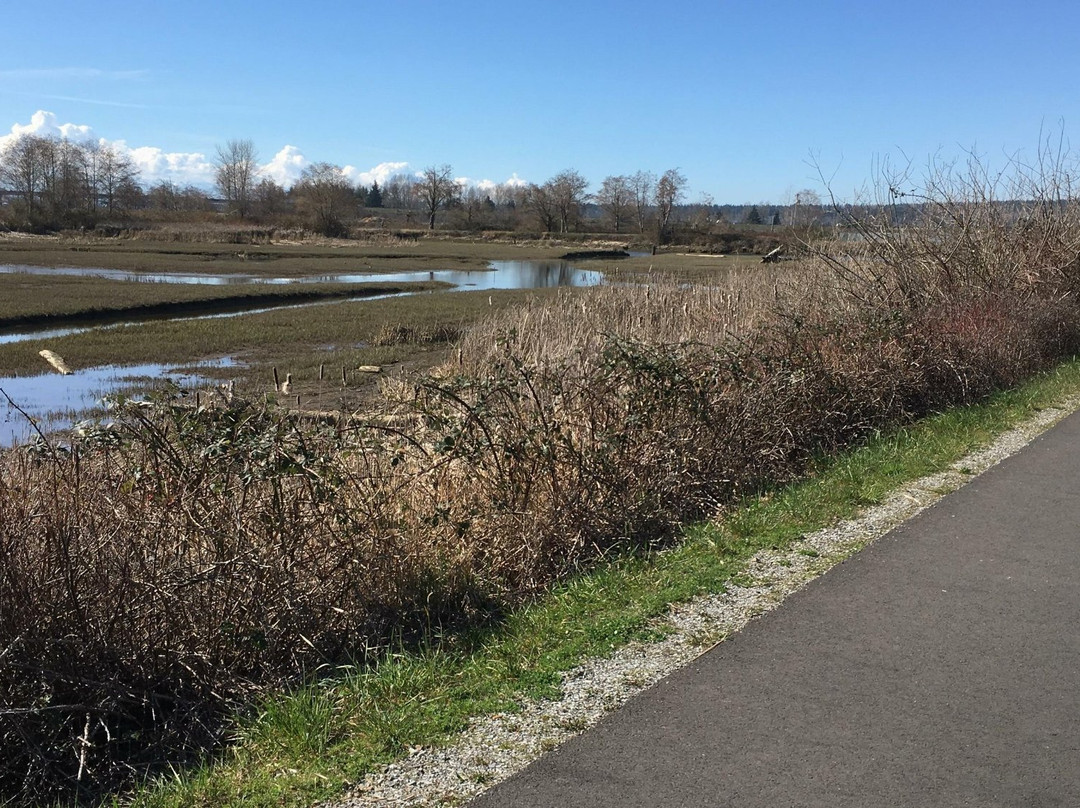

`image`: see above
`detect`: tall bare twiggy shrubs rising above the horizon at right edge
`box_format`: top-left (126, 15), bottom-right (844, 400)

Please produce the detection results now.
top-left (815, 143), bottom-right (1080, 307)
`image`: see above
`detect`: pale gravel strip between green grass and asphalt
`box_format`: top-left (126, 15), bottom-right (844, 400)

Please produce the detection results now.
top-left (323, 399), bottom-right (1080, 808)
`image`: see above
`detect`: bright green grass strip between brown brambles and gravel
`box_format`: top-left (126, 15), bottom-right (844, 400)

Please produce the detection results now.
top-left (132, 360), bottom-right (1080, 808)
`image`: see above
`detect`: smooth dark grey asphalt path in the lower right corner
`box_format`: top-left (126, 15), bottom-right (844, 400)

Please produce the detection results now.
top-left (470, 415), bottom-right (1080, 808)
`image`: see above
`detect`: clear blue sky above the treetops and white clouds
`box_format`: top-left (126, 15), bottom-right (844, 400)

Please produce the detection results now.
top-left (0, 0), bottom-right (1080, 203)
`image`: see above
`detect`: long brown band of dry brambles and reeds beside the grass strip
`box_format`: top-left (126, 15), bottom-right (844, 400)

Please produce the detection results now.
top-left (0, 156), bottom-right (1080, 802)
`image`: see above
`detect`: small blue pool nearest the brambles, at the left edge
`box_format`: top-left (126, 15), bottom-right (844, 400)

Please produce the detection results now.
top-left (0, 358), bottom-right (235, 446)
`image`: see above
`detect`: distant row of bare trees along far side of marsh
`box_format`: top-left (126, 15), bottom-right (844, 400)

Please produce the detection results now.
top-left (0, 135), bottom-right (824, 239)
